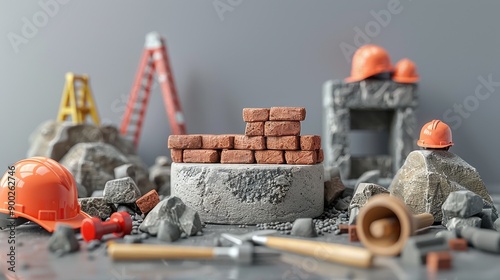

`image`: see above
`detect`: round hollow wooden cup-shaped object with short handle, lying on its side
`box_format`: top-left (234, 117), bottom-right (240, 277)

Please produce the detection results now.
top-left (356, 194), bottom-right (434, 256)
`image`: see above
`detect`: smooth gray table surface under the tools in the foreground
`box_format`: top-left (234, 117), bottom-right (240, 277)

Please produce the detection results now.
top-left (0, 196), bottom-right (500, 280)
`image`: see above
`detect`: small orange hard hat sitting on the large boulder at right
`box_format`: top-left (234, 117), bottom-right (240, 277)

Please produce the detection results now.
top-left (417, 120), bottom-right (453, 148)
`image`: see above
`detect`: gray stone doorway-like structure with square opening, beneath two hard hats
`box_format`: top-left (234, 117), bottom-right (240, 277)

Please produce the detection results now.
top-left (323, 80), bottom-right (418, 179)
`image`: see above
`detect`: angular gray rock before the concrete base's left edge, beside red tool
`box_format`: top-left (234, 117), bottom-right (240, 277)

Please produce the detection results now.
top-left (139, 196), bottom-right (202, 236)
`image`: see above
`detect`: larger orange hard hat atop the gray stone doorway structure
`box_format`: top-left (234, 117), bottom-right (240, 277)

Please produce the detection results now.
top-left (345, 45), bottom-right (393, 82)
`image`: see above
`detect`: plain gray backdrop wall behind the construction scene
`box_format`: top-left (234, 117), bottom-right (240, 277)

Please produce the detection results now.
top-left (0, 0), bottom-right (500, 192)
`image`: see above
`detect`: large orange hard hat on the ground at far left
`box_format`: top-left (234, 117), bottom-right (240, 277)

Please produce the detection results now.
top-left (0, 157), bottom-right (90, 232)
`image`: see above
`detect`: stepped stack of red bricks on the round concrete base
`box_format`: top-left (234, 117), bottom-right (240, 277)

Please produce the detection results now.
top-left (168, 107), bottom-right (323, 164)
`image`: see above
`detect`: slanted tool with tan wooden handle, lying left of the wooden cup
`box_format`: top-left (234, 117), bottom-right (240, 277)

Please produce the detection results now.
top-left (221, 232), bottom-right (373, 268)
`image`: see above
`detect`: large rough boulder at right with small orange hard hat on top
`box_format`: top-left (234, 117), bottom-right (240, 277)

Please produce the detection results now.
top-left (389, 150), bottom-right (497, 222)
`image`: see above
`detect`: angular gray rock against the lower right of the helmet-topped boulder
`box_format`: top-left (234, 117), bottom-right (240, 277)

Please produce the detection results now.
top-left (441, 191), bottom-right (483, 224)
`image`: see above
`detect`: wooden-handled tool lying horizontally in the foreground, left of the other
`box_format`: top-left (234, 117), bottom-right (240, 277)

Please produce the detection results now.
top-left (108, 242), bottom-right (278, 264)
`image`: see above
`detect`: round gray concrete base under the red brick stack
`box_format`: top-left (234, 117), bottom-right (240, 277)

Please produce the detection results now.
top-left (171, 163), bottom-right (324, 224)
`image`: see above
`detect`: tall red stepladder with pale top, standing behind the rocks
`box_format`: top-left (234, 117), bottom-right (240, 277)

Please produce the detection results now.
top-left (120, 32), bottom-right (186, 147)
